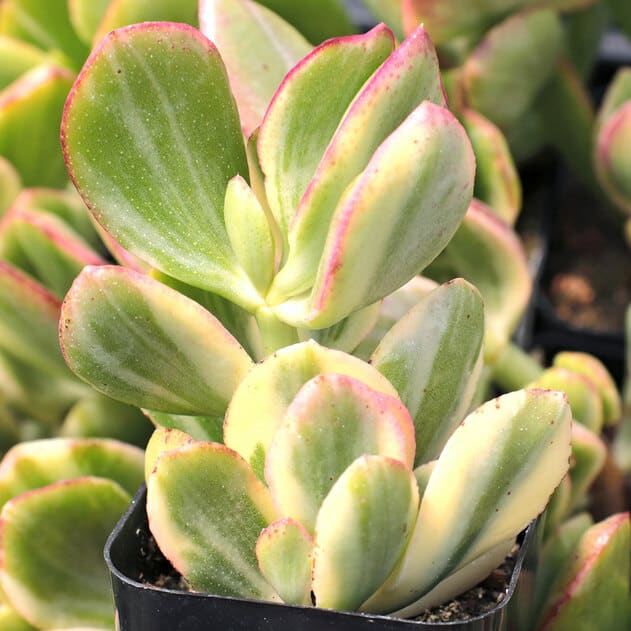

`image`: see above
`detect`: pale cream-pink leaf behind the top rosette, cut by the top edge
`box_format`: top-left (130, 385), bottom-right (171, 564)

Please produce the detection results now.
top-left (199, 0), bottom-right (311, 136)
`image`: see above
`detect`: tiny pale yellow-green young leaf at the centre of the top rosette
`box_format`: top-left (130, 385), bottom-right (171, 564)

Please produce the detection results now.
top-left (223, 176), bottom-right (275, 294)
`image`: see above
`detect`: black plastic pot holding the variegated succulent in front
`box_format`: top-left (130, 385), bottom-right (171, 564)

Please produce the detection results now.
top-left (105, 487), bottom-right (539, 631)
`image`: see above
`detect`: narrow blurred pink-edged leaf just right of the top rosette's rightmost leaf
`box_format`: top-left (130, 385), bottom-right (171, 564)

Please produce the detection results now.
top-left (462, 109), bottom-right (521, 226)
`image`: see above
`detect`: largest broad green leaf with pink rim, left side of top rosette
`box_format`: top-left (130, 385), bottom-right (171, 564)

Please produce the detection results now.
top-left (62, 23), bottom-right (260, 308)
